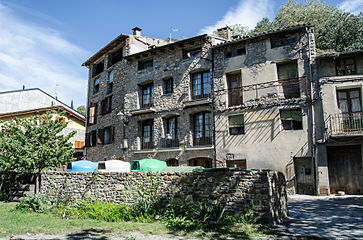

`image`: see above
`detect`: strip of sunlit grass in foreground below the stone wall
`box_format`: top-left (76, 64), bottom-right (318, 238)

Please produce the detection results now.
top-left (0, 202), bottom-right (322, 239)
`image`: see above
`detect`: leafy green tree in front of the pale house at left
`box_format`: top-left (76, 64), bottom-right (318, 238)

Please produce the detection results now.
top-left (0, 111), bottom-right (75, 191)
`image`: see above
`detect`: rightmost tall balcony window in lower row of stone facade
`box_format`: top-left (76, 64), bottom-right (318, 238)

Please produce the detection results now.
top-left (194, 112), bottom-right (212, 145)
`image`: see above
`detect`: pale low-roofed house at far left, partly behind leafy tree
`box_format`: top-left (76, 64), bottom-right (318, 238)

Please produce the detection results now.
top-left (0, 88), bottom-right (86, 159)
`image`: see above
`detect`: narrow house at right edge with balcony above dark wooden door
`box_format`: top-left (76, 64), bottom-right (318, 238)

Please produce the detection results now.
top-left (314, 51), bottom-right (363, 195)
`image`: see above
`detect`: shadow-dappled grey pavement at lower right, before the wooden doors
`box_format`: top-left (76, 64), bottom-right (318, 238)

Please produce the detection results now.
top-left (273, 195), bottom-right (363, 239)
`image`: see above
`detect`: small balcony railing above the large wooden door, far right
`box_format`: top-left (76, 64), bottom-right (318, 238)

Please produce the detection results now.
top-left (327, 112), bottom-right (363, 136)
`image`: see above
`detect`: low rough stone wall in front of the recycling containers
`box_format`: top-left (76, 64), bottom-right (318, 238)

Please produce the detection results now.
top-left (41, 170), bottom-right (287, 224)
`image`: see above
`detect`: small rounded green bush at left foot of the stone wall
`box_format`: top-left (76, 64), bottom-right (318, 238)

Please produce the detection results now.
top-left (15, 195), bottom-right (52, 212)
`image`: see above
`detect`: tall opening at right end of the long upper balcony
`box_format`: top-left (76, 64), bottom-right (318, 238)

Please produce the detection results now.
top-left (277, 61), bottom-right (300, 98)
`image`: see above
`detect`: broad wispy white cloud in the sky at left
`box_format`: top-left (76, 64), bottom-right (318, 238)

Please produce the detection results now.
top-left (0, 3), bottom-right (90, 106)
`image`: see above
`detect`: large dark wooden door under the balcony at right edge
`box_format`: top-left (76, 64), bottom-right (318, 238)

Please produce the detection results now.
top-left (327, 145), bottom-right (363, 194)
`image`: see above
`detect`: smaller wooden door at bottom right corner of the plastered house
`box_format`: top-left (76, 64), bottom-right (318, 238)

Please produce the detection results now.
top-left (294, 158), bottom-right (314, 195)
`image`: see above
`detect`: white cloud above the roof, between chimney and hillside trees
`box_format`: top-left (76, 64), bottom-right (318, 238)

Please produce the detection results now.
top-left (199, 0), bottom-right (273, 34)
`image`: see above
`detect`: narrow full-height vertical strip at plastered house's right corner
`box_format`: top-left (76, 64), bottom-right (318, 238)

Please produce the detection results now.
top-left (305, 27), bottom-right (318, 195)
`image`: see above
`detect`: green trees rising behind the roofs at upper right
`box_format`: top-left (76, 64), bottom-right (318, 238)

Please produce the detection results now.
top-left (252, 0), bottom-right (363, 52)
